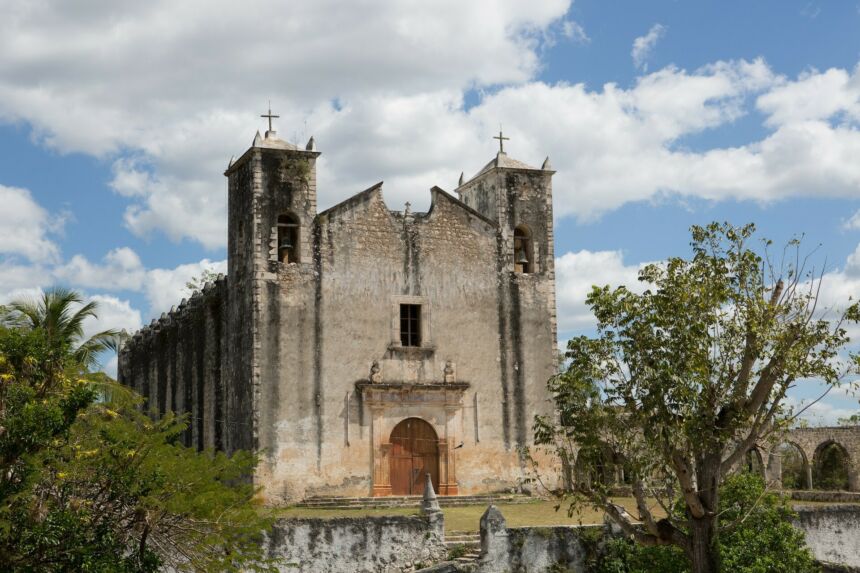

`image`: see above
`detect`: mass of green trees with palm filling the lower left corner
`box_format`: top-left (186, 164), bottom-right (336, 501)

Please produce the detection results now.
top-left (0, 289), bottom-right (270, 573)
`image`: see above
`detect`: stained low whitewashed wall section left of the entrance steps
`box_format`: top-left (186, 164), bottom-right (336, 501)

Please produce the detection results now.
top-left (267, 514), bottom-right (446, 573)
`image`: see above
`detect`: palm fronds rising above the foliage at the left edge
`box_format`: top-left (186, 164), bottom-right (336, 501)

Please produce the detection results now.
top-left (0, 287), bottom-right (119, 370)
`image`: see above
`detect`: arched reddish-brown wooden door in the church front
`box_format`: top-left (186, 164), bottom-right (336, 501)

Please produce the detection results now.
top-left (390, 418), bottom-right (439, 495)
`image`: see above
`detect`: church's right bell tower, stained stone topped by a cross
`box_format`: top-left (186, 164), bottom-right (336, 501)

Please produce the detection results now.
top-left (456, 131), bottom-right (557, 449)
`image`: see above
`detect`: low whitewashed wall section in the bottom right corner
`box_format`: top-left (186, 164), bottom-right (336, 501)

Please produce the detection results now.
top-left (794, 505), bottom-right (860, 570)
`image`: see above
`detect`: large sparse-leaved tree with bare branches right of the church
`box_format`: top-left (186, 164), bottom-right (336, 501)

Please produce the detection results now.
top-left (535, 223), bottom-right (860, 573)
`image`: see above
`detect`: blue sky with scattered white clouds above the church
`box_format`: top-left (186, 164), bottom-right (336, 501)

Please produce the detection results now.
top-left (0, 0), bottom-right (860, 423)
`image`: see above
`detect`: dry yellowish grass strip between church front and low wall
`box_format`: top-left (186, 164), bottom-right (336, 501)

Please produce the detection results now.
top-left (276, 498), bottom-right (660, 533)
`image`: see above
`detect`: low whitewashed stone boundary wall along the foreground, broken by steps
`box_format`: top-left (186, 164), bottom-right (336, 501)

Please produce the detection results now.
top-left (266, 498), bottom-right (860, 573)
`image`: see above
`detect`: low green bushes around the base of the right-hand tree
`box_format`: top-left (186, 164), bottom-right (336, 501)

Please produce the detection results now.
top-left (595, 473), bottom-right (819, 573)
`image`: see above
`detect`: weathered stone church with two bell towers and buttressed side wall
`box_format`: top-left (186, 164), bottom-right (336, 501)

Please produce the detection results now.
top-left (119, 124), bottom-right (557, 504)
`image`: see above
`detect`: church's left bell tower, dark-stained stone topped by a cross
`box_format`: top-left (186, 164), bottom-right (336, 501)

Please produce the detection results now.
top-left (224, 110), bottom-right (320, 454)
